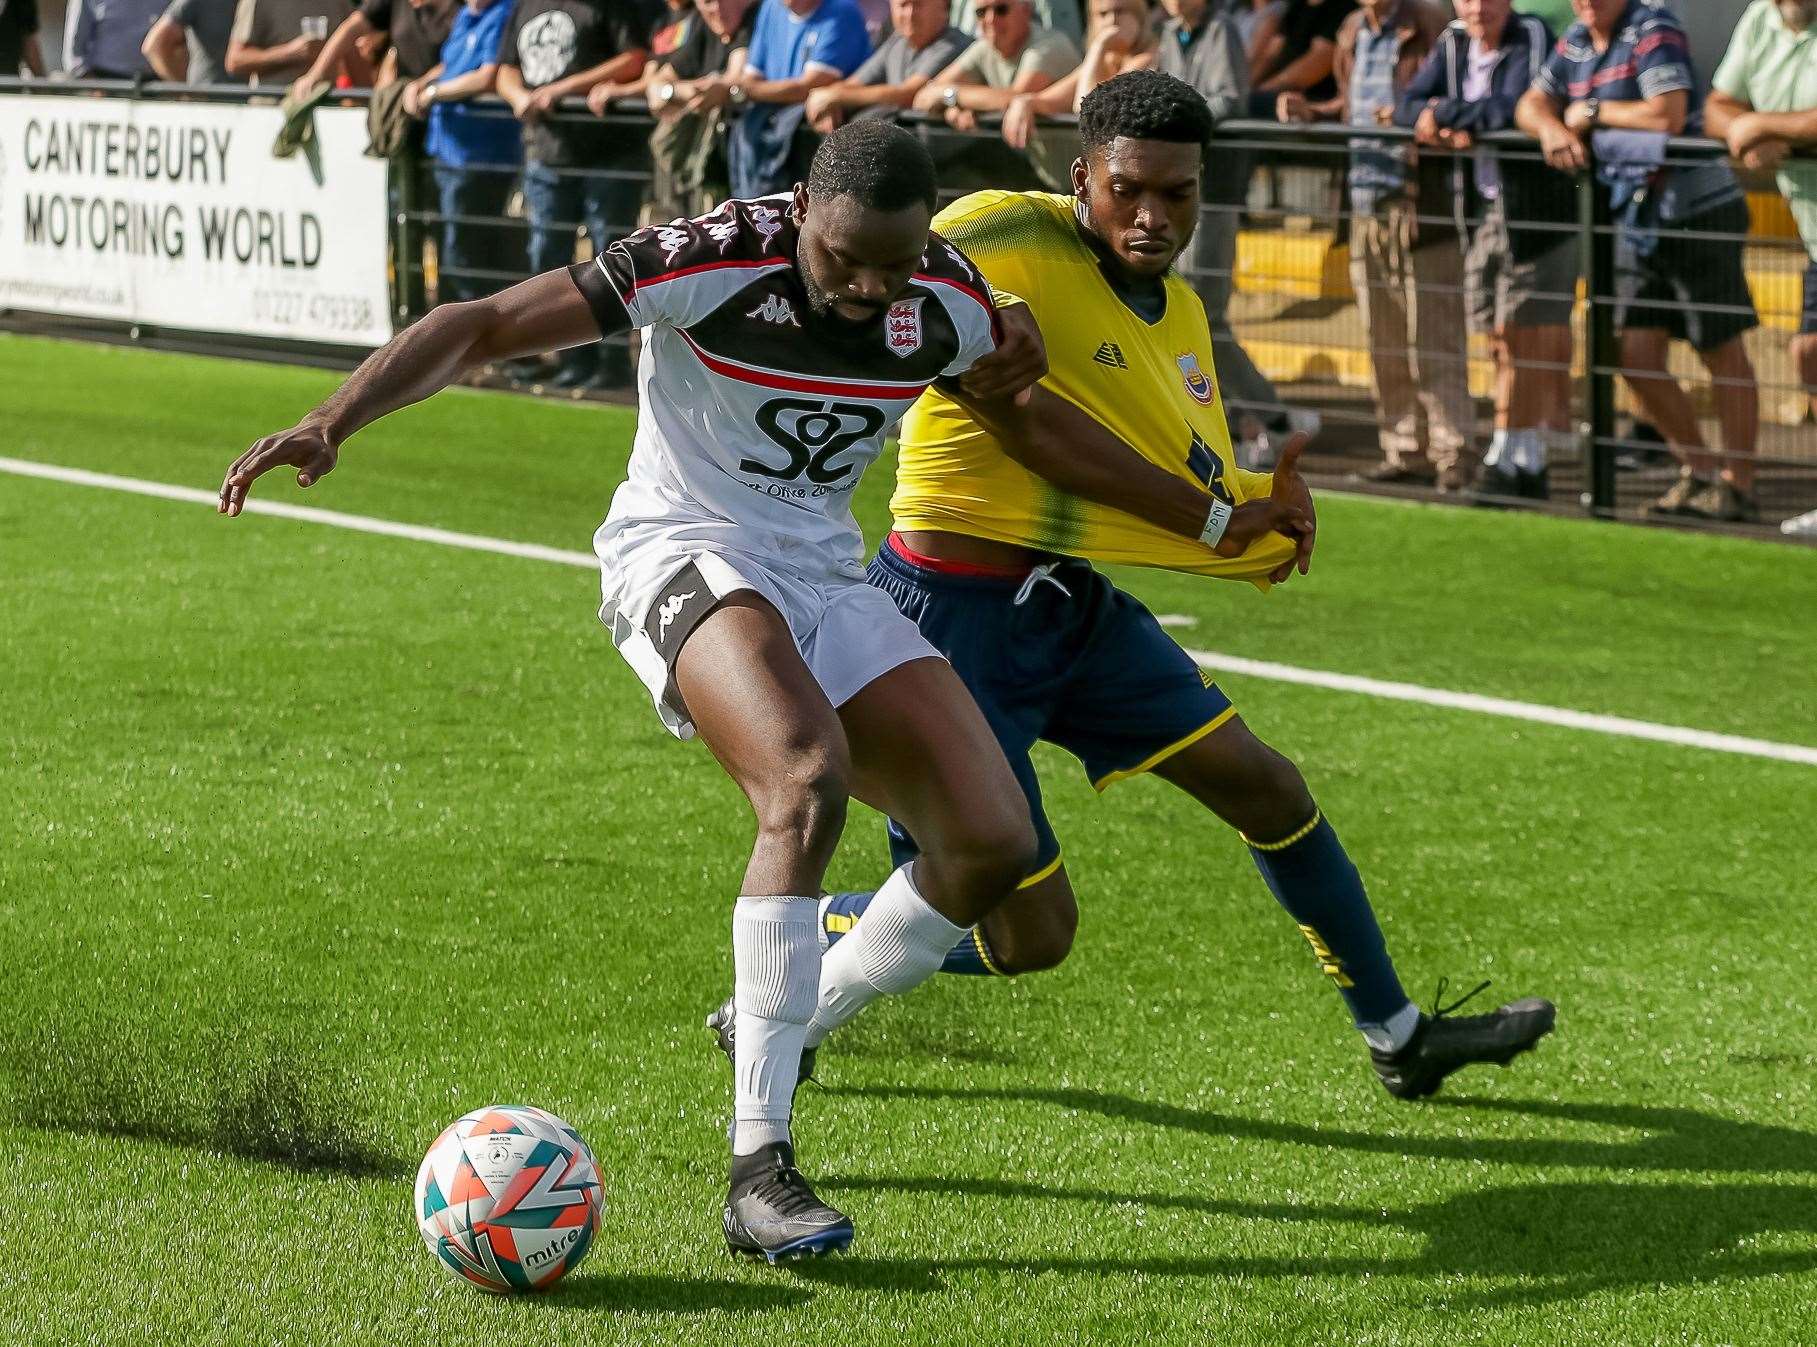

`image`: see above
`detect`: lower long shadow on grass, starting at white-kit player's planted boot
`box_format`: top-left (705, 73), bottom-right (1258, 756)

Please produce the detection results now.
top-left (799, 1178), bottom-right (1817, 1309)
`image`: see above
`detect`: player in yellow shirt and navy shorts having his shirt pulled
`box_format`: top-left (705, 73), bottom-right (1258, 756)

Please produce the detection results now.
top-left (821, 71), bottom-right (1555, 1098)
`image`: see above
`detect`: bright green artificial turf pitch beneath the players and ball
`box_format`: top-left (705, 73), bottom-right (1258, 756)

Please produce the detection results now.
top-left (0, 329), bottom-right (1817, 1347)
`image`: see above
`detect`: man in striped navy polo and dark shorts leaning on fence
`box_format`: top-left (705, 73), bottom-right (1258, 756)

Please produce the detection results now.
top-left (1515, 0), bottom-right (1761, 522)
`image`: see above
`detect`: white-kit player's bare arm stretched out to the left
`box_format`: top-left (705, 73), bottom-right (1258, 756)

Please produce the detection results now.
top-left (218, 269), bottom-right (603, 516)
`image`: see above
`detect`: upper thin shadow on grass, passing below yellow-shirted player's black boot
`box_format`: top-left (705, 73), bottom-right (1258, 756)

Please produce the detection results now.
top-left (829, 1085), bottom-right (1817, 1174)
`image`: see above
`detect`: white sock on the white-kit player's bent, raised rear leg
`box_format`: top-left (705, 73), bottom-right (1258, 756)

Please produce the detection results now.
top-left (807, 865), bottom-right (965, 1047)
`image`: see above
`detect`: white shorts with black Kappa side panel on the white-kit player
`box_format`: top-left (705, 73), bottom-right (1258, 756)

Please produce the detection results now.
top-left (596, 524), bottom-right (945, 740)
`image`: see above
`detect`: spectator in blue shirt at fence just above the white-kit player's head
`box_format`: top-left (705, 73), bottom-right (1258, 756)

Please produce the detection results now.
top-left (727, 0), bottom-right (870, 196)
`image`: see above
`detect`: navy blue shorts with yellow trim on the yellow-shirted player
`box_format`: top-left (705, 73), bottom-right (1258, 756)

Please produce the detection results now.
top-left (869, 542), bottom-right (1236, 883)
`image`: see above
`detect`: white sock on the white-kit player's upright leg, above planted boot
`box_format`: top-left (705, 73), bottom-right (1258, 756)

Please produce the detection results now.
top-left (732, 898), bottom-right (819, 1156)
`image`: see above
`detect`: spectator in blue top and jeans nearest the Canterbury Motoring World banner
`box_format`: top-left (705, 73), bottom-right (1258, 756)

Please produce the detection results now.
top-left (403, 0), bottom-right (523, 300)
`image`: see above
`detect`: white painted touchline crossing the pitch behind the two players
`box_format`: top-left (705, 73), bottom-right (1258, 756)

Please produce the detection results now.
top-left (14, 456), bottom-right (1817, 767)
